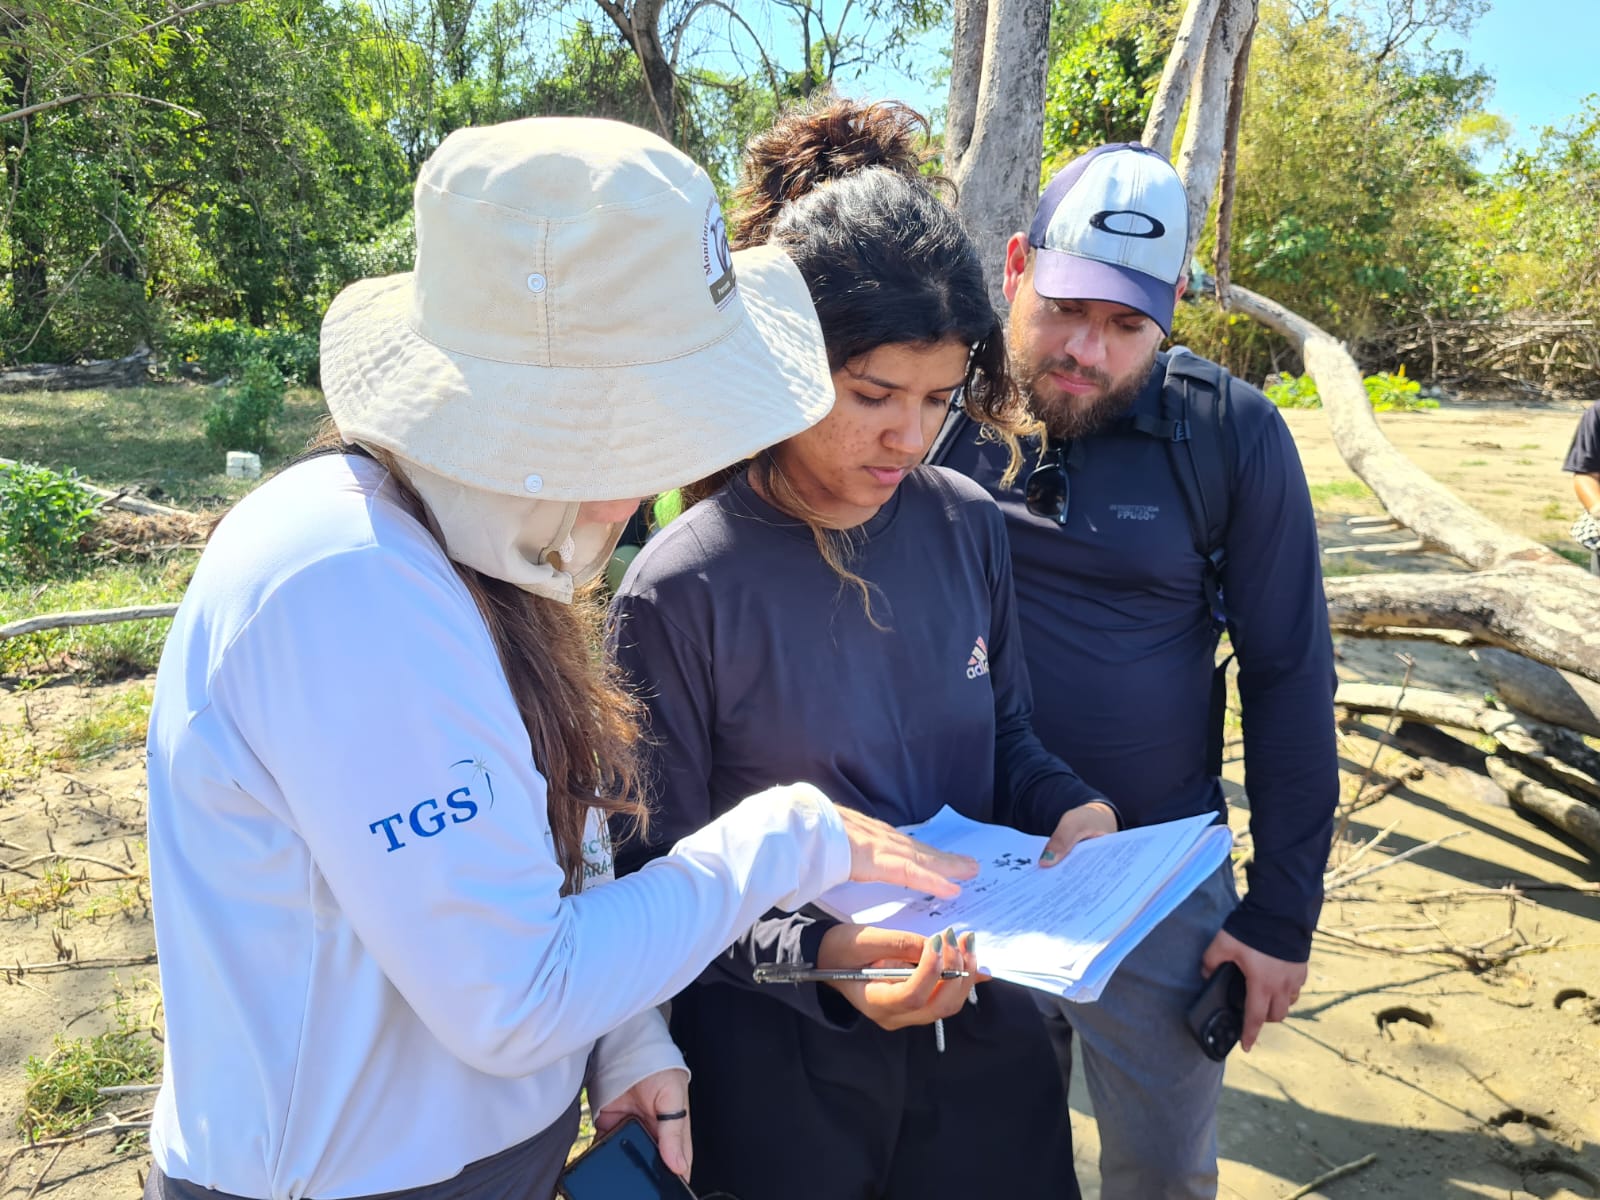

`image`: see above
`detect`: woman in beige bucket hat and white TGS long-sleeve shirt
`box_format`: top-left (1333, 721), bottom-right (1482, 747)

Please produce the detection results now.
top-left (146, 120), bottom-right (973, 1200)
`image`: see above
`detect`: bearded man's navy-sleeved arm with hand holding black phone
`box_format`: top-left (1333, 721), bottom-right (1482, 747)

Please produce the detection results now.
top-left (1203, 401), bottom-right (1339, 1050)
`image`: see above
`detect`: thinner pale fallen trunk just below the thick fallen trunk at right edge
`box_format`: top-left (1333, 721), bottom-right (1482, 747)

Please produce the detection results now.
top-left (1334, 683), bottom-right (1600, 803)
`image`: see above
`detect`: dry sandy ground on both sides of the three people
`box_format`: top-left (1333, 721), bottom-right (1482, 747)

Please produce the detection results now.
top-left (0, 406), bottom-right (1600, 1200)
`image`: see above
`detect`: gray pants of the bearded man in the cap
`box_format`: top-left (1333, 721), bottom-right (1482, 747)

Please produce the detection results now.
top-left (1034, 862), bottom-right (1238, 1200)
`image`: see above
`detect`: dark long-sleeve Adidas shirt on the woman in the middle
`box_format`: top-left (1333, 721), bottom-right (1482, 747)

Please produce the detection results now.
top-left (610, 467), bottom-right (1102, 1021)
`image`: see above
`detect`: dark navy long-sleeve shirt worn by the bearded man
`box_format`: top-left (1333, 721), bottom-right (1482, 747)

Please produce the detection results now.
top-left (941, 355), bottom-right (1339, 962)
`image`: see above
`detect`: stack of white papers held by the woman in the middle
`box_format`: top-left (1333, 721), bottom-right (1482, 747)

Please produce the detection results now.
top-left (816, 806), bottom-right (1234, 1002)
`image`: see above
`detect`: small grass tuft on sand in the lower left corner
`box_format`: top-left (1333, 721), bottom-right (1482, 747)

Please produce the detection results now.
top-left (16, 997), bottom-right (162, 1141)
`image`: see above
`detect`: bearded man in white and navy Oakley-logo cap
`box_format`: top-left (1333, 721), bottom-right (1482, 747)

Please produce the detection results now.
top-left (939, 144), bottom-right (1338, 1200)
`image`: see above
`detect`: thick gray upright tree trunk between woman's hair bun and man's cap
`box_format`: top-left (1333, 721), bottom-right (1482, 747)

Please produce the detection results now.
top-left (950, 0), bottom-right (1050, 312)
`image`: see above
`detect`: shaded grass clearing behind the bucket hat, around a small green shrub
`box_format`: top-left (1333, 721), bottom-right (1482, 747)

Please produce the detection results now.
top-left (0, 384), bottom-right (328, 509)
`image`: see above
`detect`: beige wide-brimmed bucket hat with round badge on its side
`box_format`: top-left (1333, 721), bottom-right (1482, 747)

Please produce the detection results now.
top-left (322, 118), bottom-right (834, 505)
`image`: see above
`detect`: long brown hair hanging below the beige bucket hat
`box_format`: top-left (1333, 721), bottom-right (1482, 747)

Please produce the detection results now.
top-left (310, 422), bottom-right (648, 894)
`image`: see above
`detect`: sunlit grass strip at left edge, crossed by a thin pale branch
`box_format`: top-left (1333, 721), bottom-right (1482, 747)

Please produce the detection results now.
top-left (0, 554), bottom-right (188, 682)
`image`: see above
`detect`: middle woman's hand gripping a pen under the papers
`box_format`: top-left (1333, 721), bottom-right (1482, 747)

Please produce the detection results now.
top-left (816, 925), bottom-right (981, 1029)
